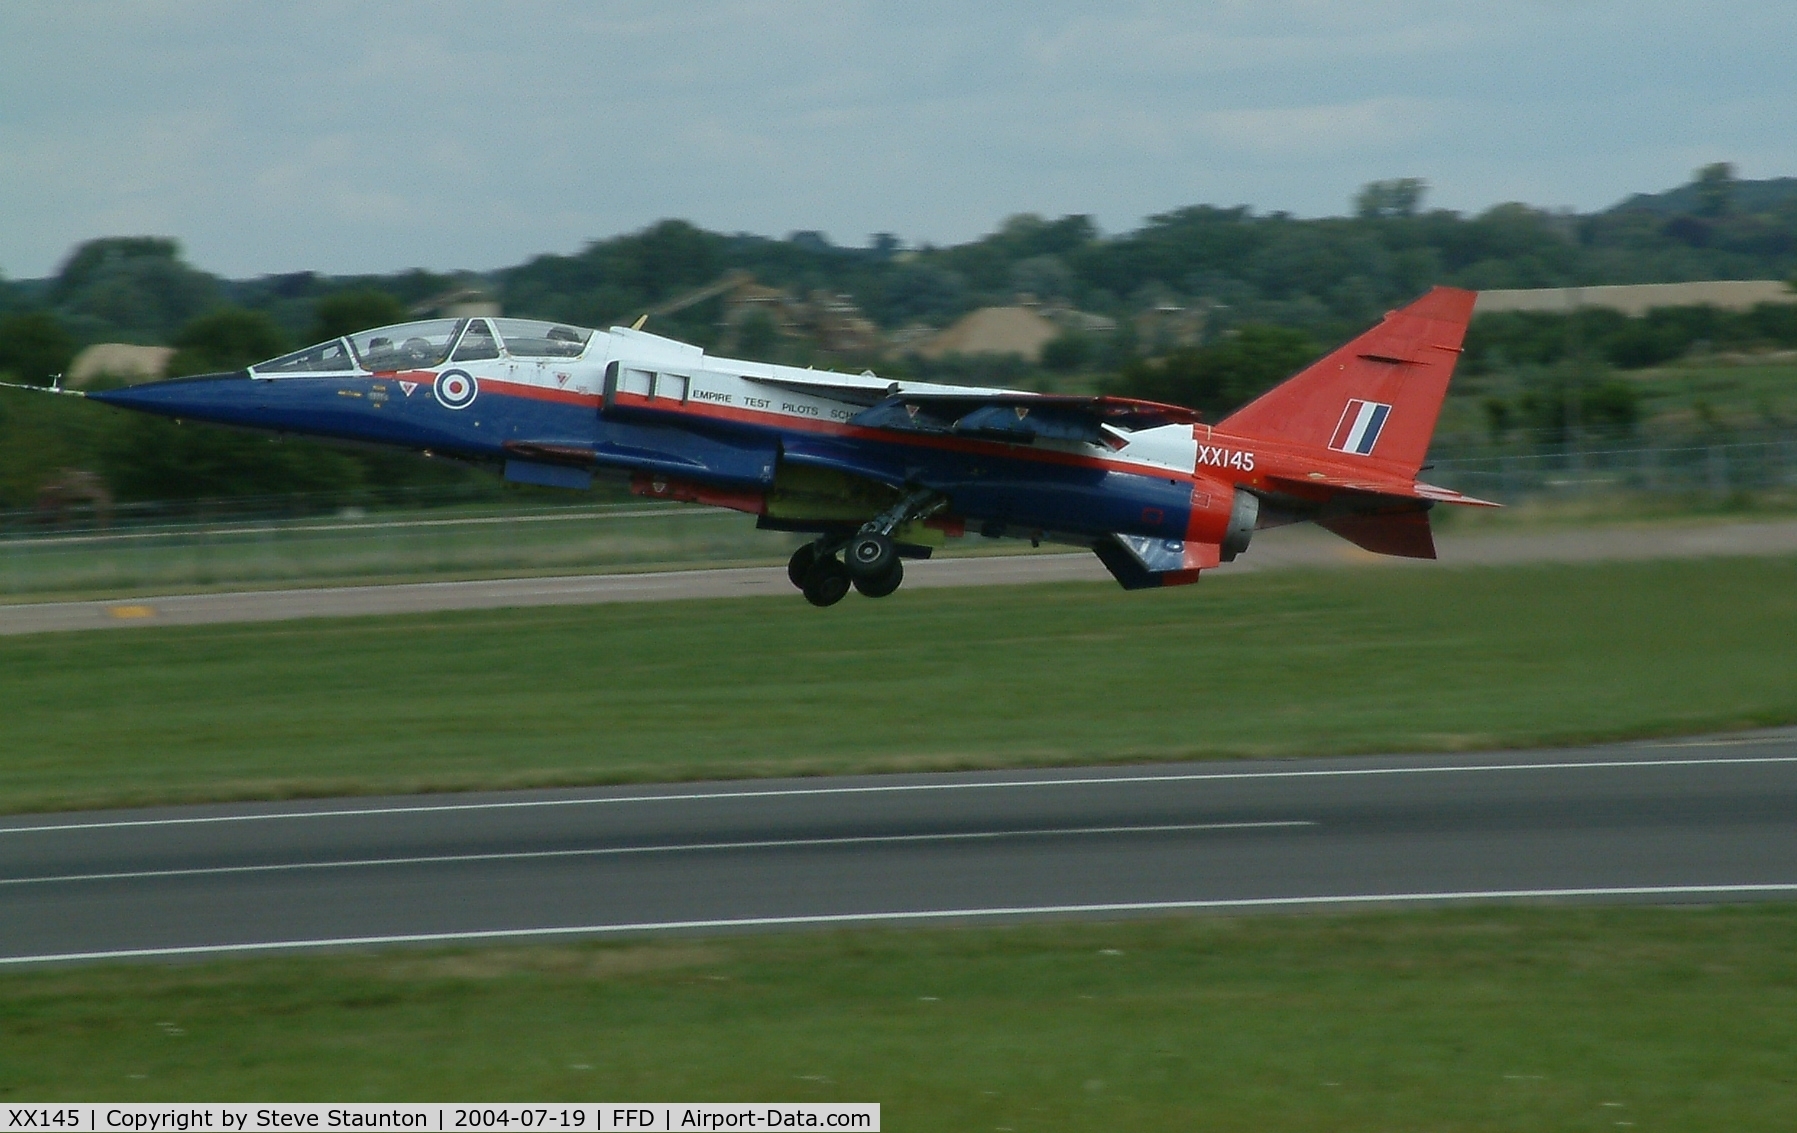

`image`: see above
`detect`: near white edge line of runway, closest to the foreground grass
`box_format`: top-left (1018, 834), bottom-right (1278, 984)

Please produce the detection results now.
top-left (0, 883), bottom-right (1797, 964)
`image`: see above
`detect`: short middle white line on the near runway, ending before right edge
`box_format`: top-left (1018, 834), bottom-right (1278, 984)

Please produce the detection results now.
top-left (0, 822), bottom-right (1315, 885)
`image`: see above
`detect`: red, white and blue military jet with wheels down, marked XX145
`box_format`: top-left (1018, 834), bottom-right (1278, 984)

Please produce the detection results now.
top-left (49, 288), bottom-right (1486, 606)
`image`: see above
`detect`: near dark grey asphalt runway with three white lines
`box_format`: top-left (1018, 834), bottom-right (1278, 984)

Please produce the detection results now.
top-left (0, 730), bottom-right (1797, 966)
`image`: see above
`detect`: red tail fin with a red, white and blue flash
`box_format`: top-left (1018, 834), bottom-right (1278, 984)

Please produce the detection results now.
top-left (1217, 288), bottom-right (1477, 477)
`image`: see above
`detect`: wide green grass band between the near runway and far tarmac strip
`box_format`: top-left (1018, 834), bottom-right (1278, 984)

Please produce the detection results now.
top-left (0, 559), bottom-right (1797, 811)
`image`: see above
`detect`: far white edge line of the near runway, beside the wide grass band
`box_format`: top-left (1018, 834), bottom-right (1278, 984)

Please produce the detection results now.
top-left (0, 755), bottom-right (1797, 834)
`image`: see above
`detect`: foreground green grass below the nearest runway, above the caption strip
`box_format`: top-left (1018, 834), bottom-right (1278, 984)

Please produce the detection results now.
top-left (0, 905), bottom-right (1797, 1131)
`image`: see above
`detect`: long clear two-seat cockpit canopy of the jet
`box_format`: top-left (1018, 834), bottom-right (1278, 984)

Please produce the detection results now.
top-left (250, 318), bottom-right (593, 378)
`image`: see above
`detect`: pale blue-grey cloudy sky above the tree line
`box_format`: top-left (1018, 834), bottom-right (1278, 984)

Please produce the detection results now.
top-left (0, 0), bottom-right (1797, 279)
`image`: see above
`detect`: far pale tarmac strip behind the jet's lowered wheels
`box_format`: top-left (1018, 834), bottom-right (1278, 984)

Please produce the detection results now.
top-left (0, 520), bottom-right (1797, 635)
